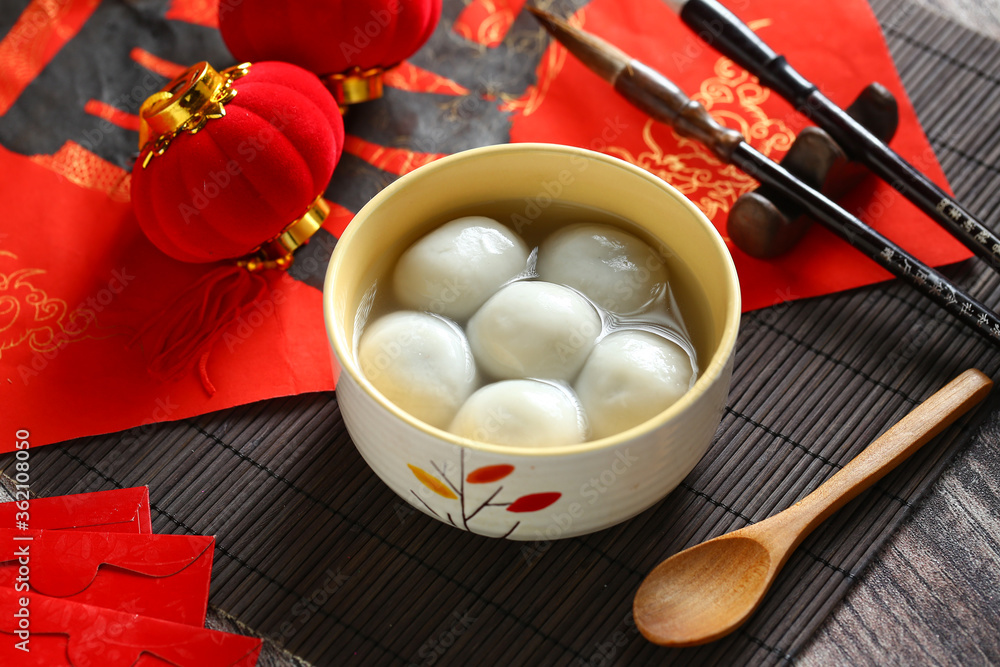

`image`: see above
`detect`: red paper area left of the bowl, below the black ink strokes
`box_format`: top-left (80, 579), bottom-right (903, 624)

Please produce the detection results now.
top-left (0, 147), bottom-right (335, 450)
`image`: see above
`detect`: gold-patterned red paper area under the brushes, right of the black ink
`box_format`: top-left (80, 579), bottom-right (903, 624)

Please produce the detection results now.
top-left (509, 0), bottom-right (971, 310)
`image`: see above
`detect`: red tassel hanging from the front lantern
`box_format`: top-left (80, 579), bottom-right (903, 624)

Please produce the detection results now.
top-left (131, 264), bottom-right (267, 396)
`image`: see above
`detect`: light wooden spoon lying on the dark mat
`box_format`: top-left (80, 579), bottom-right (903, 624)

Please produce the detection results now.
top-left (633, 369), bottom-right (993, 646)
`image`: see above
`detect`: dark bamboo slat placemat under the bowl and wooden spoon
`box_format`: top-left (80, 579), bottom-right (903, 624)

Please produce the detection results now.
top-left (2, 0), bottom-right (1000, 666)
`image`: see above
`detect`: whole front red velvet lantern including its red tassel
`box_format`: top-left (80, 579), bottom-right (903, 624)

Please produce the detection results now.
top-left (132, 62), bottom-right (344, 394)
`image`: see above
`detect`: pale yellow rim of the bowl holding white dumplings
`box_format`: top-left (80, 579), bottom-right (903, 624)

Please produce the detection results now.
top-left (322, 142), bottom-right (742, 457)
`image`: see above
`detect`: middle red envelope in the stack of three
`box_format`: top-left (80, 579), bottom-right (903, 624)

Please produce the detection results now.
top-left (0, 530), bottom-right (215, 626)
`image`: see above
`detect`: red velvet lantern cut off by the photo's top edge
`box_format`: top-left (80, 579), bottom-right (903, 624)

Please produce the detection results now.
top-left (219, 0), bottom-right (441, 105)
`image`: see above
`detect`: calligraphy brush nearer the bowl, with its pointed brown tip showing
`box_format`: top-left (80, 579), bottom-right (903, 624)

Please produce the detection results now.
top-left (529, 7), bottom-right (1000, 346)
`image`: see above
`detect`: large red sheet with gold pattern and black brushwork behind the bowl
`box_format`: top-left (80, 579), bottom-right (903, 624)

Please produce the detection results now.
top-left (0, 0), bottom-right (969, 452)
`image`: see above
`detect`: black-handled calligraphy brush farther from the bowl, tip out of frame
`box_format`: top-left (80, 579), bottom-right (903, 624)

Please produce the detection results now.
top-left (664, 0), bottom-right (1000, 270)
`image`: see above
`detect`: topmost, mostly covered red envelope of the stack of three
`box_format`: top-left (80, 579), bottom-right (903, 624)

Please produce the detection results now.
top-left (0, 486), bottom-right (153, 535)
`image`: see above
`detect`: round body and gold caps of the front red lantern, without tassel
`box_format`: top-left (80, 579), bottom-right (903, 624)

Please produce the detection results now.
top-left (132, 62), bottom-right (344, 262)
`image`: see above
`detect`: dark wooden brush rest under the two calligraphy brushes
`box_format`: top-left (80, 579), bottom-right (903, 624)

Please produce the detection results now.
top-left (727, 83), bottom-right (899, 259)
